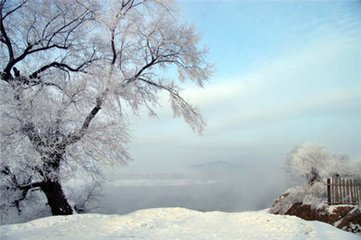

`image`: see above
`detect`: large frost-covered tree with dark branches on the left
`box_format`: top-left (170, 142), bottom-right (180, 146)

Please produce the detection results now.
top-left (0, 0), bottom-right (210, 215)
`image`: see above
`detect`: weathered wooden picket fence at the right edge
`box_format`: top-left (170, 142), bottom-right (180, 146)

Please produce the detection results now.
top-left (327, 177), bottom-right (361, 205)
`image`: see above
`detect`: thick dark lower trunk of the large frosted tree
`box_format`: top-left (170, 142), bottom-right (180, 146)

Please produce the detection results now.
top-left (41, 180), bottom-right (73, 215)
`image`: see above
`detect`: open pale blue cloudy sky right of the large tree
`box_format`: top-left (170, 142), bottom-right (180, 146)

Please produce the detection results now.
top-left (119, 0), bottom-right (361, 172)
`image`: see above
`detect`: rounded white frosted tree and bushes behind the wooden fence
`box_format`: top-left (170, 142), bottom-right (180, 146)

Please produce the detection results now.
top-left (286, 143), bottom-right (361, 185)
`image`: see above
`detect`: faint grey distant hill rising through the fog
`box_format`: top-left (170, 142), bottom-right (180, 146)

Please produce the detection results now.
top-left (189, 161), bottom-right (244, 177)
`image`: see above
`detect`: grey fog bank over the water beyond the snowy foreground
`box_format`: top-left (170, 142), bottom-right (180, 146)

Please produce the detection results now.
top-left (93, 162), bottom-right (291, 214)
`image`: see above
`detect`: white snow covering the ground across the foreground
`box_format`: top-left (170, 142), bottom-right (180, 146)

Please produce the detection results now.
top-left (0, 208), bottom-right (361, 240)
